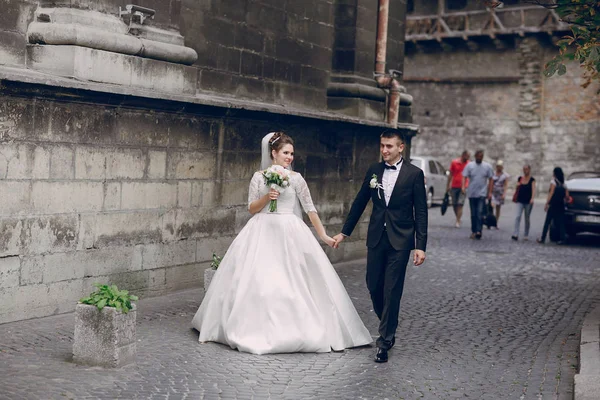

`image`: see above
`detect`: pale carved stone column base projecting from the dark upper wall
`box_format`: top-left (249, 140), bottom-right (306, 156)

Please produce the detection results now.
top-left (26, 6), bottom-right (198, 95)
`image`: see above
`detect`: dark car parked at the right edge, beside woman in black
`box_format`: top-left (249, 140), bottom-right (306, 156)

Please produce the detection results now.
top-left (565, 171), bottom-right (600, 237)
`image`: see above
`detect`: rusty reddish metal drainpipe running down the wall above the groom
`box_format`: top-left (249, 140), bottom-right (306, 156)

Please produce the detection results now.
top-left (373, 0), bottom-right (402, 127)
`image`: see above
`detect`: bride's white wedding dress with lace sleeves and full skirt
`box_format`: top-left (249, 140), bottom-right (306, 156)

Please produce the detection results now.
top-left (192, 172), bottom-right (372, 354)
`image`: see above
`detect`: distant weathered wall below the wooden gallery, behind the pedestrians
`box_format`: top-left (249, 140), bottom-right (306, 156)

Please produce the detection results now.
top-left (405, 36), bottom-right (600, 192)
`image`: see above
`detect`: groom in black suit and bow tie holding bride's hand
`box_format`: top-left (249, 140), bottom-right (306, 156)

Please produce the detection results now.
top-left (334, 131), bottom-right (427, 363)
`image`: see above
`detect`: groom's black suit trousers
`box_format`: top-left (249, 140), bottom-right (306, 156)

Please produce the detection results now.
top-left (367, 232), bottom-right (411, 349)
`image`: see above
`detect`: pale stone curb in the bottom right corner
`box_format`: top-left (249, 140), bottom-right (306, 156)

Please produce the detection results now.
top-left (575, 306), bottom-right (600, 400)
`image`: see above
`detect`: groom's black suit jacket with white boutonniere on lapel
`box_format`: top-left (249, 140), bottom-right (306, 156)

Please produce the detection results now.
top-left (342, 160), bottom-right (427, 251)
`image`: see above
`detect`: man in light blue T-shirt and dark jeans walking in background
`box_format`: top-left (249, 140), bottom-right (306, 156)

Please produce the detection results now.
top-left (462, 150), bottom-right (494, 239)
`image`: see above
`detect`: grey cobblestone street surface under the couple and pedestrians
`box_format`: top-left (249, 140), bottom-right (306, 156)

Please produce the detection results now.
top-left (0, 205), bottom-right (600, 399)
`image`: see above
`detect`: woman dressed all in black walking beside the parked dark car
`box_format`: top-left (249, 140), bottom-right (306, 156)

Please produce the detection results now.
top-left (537, 167), bottom-right (569, 244)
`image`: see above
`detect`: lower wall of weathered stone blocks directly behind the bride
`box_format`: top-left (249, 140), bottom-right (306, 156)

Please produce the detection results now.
top-left (0, 88), bottom-right (381, 323)
